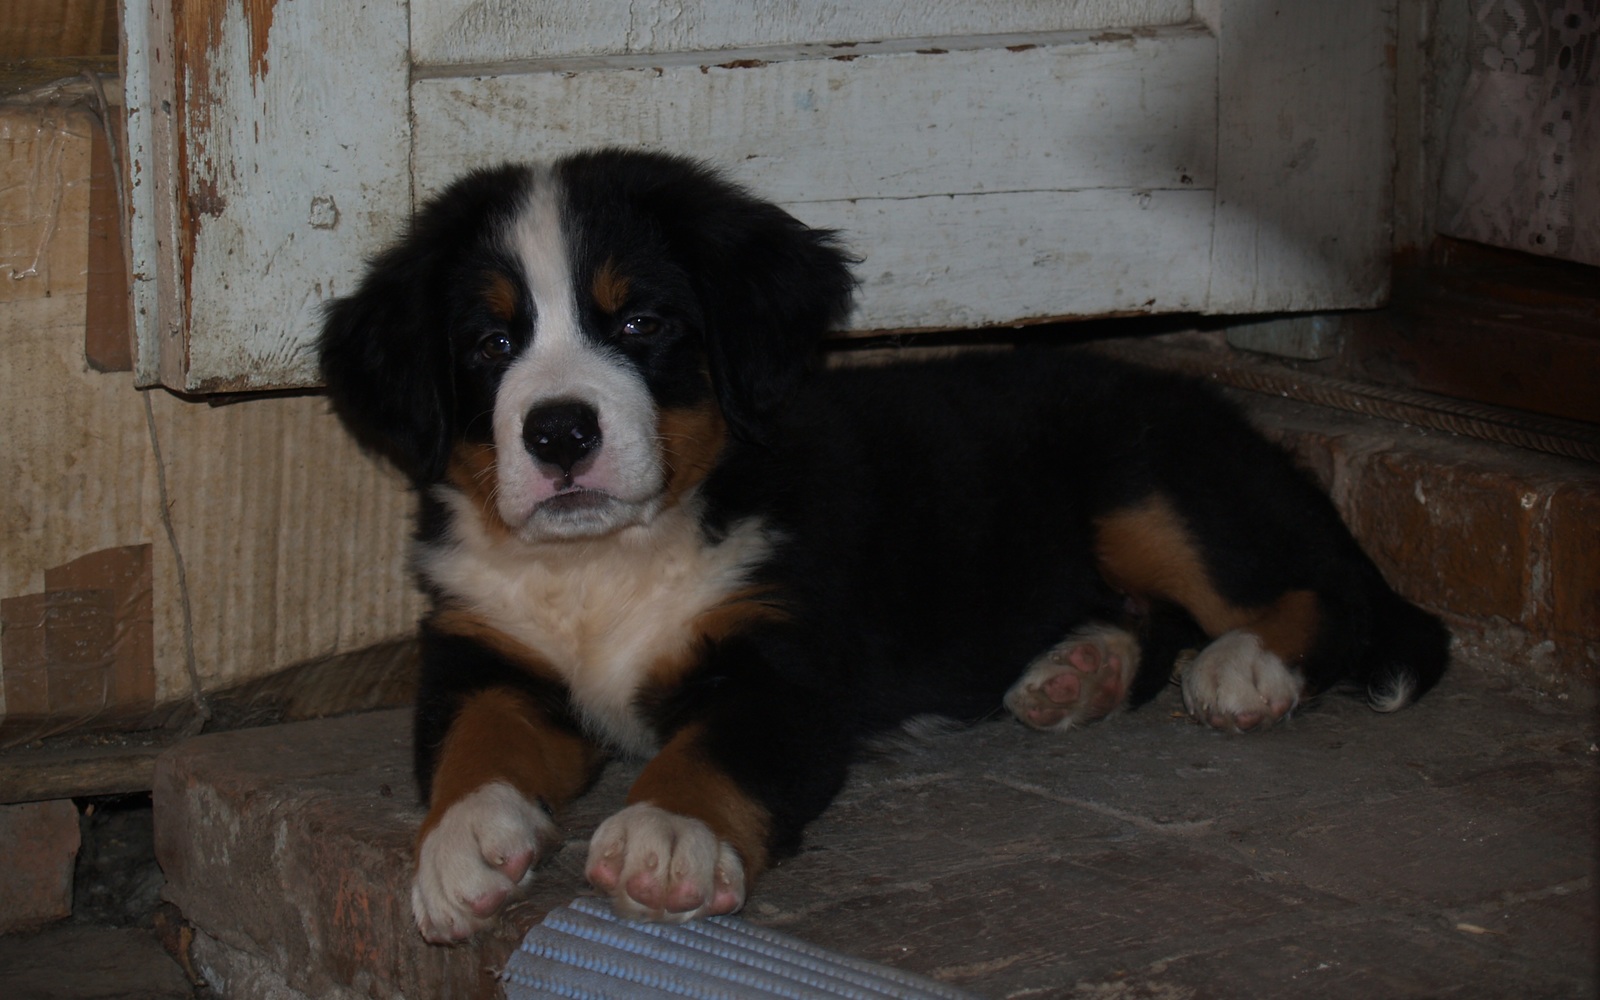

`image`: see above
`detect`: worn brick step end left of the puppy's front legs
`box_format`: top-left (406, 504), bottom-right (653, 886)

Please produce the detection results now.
top-left (154, 712), bottom-right (525, 1000)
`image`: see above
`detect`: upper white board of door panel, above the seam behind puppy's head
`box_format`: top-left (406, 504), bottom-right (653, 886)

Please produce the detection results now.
top-left (413, 27), bottom-right (1216, 203)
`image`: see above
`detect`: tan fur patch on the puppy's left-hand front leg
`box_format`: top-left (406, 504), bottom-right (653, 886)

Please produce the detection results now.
top-left (416, 688), bottom-right (600, 845)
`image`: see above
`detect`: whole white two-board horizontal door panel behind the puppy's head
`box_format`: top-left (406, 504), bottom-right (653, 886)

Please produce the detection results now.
top-left (413, 27), bottom-right (1216, 330)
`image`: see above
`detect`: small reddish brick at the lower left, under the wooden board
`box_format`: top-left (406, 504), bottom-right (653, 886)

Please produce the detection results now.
top-left (0, 800), bottom-right (80, 933)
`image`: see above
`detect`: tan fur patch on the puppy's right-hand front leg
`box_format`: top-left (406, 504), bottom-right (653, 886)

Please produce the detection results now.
top-left (627, 725), bottom-right (771, 883)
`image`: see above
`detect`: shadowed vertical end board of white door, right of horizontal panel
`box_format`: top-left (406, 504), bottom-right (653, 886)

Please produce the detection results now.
top-left (1206, 0), bottom-right (1394, 314)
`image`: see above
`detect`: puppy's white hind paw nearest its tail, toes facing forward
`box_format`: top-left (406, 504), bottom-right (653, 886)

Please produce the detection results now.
top-left (1182, 629), bottom-right (1301, 731)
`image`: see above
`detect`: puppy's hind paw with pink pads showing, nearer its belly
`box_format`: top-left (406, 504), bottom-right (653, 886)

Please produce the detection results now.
top-left (1005, 626), bottom-right (1139, 731)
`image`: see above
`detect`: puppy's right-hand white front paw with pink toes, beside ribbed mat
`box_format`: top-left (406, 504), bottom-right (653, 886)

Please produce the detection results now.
top-left (584, 803), bottom-right (744, 923)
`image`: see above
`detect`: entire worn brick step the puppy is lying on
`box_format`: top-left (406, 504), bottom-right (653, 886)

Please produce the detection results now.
top-left (155, 672), bottom-right (1600, 1000)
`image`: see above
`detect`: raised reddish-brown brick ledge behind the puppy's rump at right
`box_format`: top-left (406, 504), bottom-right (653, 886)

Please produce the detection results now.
top-left (1237, 394), bottom-right (1600, 684)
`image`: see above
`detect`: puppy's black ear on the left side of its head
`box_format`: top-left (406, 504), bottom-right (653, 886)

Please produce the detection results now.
top-left (317, 249), bottom-right (451, 485)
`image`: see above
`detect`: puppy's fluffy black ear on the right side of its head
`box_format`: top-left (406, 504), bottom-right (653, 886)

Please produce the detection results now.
top-left (568, 150), bottom-right (856, 440)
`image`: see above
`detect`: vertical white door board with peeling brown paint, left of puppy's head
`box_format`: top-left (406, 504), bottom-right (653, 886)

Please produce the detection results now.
top-left (130, 0), bottom-right (410, 392)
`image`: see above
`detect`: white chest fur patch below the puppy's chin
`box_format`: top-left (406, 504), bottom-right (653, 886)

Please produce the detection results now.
top-left (418, 488), bottom-right (771, 754)
